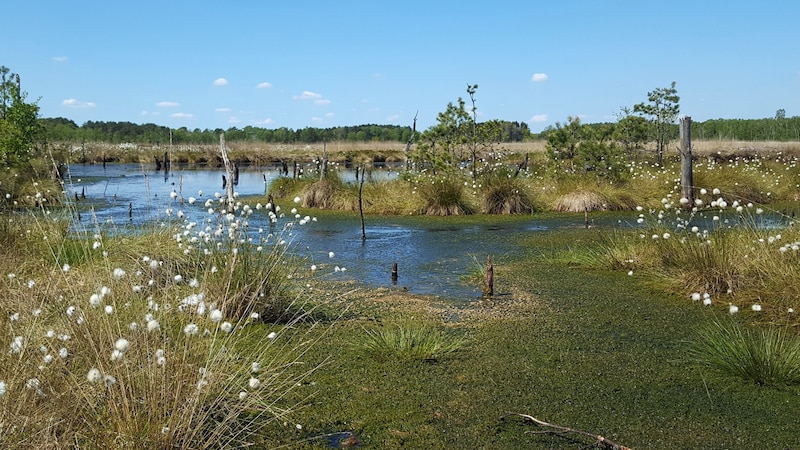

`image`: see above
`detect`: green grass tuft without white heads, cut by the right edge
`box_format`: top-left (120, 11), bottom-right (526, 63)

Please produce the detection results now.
top-left (689, 319), bottom-right (800, 386)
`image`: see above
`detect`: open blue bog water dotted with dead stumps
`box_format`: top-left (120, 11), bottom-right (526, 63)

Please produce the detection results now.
top-left (67, 164), bottom-right (616, 301)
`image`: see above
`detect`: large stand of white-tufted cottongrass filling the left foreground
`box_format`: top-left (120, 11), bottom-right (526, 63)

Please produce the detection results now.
top-left (0, 181), bottom-right (336, 449)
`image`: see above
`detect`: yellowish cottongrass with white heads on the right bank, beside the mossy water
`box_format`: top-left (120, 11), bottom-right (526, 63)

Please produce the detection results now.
top-left (594, 179), bottom-right (800, 323)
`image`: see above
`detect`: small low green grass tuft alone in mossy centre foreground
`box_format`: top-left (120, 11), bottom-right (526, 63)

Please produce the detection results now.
top-left (353, 321), bottom-right (466, 362)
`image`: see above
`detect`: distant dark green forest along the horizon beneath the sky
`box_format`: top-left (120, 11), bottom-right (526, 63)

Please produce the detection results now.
top-left (39, 115), bottom-right (800, 144)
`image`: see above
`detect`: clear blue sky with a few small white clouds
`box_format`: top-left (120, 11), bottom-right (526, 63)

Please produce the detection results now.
top-left (0, 0), bottom-right (800, 132)
